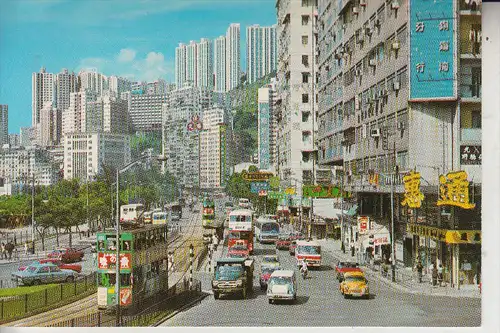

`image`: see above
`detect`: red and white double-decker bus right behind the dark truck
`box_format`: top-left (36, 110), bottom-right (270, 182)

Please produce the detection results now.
top-left (227, 209), bottom-right (254, 254)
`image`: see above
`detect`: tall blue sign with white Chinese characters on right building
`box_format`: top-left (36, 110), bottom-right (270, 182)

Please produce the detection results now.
top-left (410, 0), bottom-right (457, 101)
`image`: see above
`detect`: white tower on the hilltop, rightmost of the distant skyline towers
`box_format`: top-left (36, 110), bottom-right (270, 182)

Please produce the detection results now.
top-left (246, 24), bottom-right (277, 83)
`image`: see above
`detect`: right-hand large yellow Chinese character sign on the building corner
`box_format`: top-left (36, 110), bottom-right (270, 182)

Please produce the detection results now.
top-left (437, 171), bottom-right (476, 209)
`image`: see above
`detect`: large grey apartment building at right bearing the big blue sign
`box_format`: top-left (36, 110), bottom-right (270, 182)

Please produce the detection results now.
top-left (318, 0), bottom-right (482, 286)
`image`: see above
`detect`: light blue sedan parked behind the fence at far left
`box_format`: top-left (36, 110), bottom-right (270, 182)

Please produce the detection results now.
top-left (12, 263), bottom-right (78, 286)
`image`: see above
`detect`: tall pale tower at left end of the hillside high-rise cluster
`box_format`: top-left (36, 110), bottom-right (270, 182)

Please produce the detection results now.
top-left (31, 67), bottom-right (56, 126)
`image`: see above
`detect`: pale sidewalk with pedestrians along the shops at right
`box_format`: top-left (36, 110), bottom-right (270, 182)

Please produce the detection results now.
top-left (318, 239), bottom-right (481, 298)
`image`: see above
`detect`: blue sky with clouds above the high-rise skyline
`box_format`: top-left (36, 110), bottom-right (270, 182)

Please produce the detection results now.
top-left (0, 0), bottom-right (276, 133)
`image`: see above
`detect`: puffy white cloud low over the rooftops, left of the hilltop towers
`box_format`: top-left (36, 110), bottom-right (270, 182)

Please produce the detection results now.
top-left (78, 48), bottom-right (174, 81)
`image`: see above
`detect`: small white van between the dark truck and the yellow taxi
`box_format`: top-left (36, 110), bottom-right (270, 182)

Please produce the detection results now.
top-left (267, 270), bottom-right (297, 304)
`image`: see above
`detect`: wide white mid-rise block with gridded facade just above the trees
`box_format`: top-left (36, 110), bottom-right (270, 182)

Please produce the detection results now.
top-left (64, 133), bottom-right (131, 181)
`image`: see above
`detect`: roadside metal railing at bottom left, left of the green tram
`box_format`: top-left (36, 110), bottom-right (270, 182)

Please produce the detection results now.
top-left (0, 273), bottom-right (96, 322)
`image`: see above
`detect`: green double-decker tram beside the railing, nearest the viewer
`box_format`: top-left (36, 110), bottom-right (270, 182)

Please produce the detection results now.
top-left (97, 224), bottom-right (168, 311)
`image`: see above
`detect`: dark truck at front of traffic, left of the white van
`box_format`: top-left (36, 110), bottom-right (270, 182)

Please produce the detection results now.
top-left (212, 258), bottom-right (254, 299)
